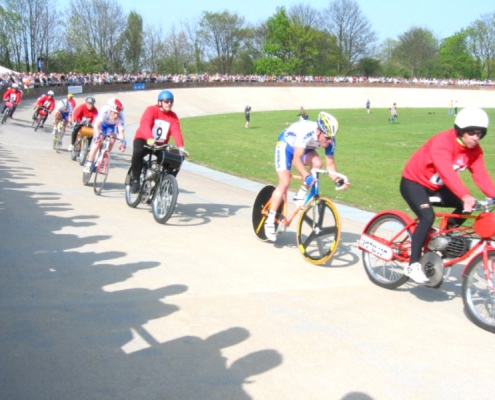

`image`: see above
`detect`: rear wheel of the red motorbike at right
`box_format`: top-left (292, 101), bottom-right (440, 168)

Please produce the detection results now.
top-left (362, 214), bottom-right (411, 289)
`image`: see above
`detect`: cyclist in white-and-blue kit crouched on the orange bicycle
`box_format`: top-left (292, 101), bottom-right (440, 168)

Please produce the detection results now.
top-left (264, 111), bottom-right (349, 242)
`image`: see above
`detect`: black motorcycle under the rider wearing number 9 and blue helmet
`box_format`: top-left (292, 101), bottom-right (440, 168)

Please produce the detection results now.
top-left (125, 144), bottom-right (187, 224)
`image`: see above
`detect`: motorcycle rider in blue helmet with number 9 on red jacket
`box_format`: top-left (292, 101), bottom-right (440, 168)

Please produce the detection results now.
top-left (131, 90), bottom-right (187, 193)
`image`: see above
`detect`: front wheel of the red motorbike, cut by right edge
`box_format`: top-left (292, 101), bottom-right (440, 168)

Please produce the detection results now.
top-left (462, 250), bottom-right (495, 333)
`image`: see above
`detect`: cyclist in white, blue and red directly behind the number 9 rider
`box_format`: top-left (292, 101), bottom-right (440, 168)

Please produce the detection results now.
top-left (83, 97), bottom-right (125, 174)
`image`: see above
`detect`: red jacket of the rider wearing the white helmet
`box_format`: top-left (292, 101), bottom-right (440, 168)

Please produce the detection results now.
top-left (402, 129), bottom-right (495, 198)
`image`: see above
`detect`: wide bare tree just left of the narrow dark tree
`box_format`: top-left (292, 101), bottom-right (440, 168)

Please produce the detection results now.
top-left (66, 0), bottom-right (127, 71)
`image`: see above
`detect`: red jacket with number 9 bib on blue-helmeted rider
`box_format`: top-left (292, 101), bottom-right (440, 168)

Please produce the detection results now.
top-left (134, 106), bottom-right (184, 147)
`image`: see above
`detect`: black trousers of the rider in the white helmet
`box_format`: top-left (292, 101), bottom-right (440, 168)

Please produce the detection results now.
top-left (400, 178), bottom-right (465, 263)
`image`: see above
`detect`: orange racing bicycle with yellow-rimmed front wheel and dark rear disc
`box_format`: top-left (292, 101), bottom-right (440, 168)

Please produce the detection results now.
top-left (252, 168), bottom-right (349, 265)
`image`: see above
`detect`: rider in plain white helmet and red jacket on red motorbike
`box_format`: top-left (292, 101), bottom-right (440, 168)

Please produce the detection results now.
top-left (400, 107), bottom-right (495, 283)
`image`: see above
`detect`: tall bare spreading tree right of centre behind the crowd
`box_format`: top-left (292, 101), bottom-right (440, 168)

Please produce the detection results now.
top-left (324, 0), bottom-right (376, 75)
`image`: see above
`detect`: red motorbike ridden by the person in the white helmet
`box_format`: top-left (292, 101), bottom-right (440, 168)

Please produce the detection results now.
top-left (358, 198), bottom-right (495, 333)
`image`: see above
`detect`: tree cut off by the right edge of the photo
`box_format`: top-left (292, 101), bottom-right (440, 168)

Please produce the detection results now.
top-left (466, 13), bottom-right (495, 78)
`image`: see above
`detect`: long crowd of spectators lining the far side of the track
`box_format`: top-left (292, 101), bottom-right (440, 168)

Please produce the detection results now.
top-left (0, 72), bottom-right (495, 89)
